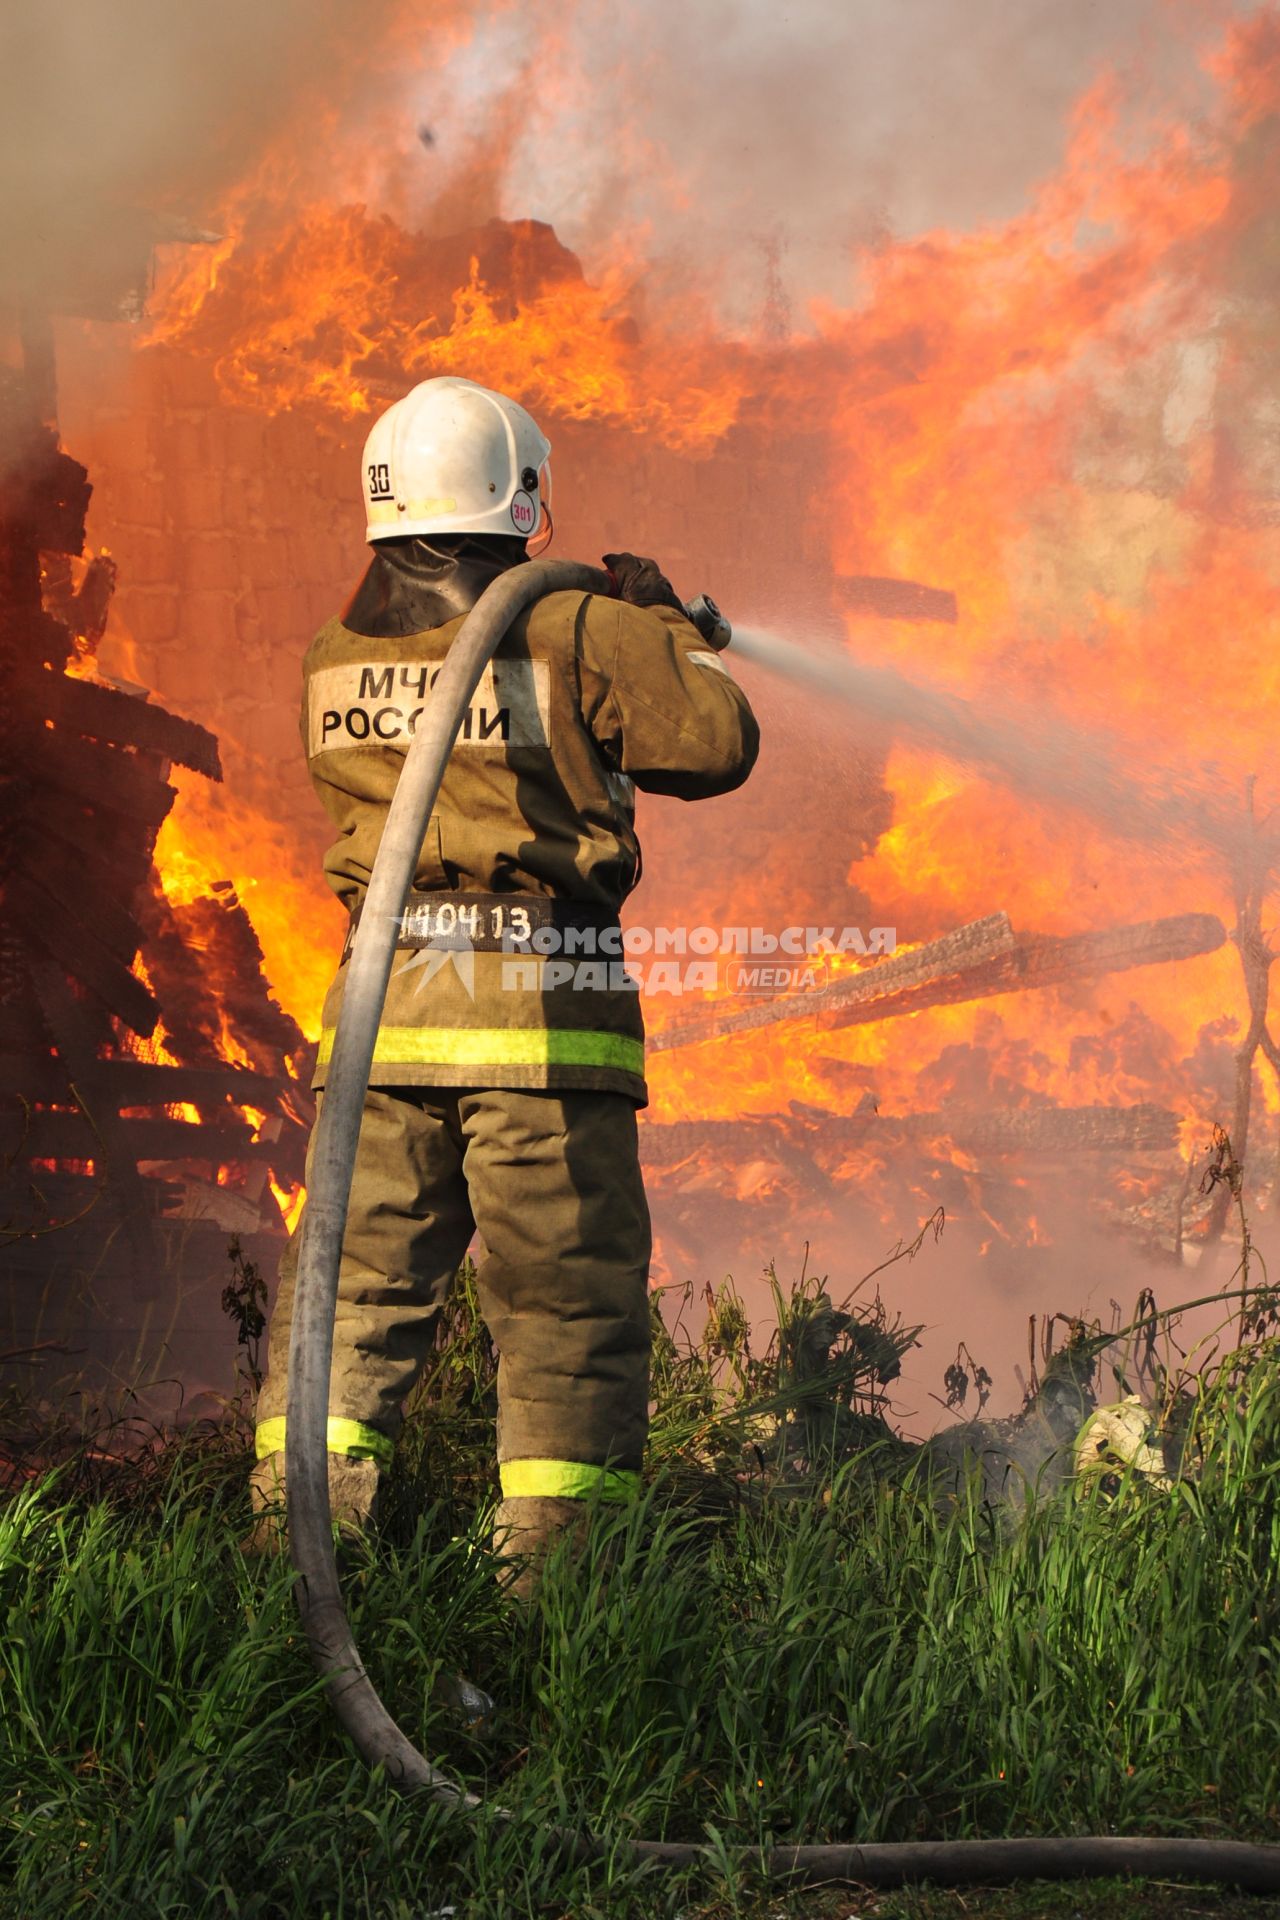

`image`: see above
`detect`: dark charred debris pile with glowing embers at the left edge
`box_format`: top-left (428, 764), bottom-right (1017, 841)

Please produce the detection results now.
top-left (0, 353), bottom-right (311, 1329)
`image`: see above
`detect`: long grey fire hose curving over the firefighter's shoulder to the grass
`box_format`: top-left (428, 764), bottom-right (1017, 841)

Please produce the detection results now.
top-left (284, 561), bottom-right (1280, 1891)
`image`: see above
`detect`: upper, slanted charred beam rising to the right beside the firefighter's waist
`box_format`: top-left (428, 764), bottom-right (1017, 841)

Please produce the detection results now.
top-left (649, 914), bottom-right (1226, 1052)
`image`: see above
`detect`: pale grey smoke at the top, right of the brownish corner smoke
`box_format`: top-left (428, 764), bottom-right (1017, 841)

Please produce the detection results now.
top-left (410, 0), bottom-right (1230, 328)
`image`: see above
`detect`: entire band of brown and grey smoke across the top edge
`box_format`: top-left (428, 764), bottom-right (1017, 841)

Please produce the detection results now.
top-left (0, 0), bottom-right (1251, 323)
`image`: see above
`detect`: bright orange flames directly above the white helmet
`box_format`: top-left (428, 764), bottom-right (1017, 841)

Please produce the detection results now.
top-left (146, 207), bottom-right (747, 451)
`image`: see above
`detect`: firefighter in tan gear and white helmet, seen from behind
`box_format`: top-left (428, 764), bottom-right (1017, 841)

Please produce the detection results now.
top-left (246, 378), bottom-right (758, 1590)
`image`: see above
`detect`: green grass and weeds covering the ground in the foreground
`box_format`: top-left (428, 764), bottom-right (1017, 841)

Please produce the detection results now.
top-left (0, 1281), bottom-right (1280, 1920)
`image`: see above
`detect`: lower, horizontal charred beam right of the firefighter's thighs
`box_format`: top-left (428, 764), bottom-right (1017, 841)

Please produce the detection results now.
top-left (641, 1102), bottom-right (1178, 1169)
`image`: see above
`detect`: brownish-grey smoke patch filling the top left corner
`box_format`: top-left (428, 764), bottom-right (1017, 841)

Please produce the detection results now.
top-left (0, 0), bottom-right (426, 311)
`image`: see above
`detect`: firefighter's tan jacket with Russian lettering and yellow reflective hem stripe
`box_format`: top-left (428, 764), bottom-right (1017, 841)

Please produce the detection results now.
top-left (301, 591), bottom-right (758, 1106)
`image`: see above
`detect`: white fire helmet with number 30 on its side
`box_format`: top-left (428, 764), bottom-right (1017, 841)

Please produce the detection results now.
top-left (363, 378), bottom-right (551, 555)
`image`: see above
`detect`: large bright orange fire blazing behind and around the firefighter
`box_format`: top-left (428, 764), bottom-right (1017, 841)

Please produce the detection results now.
top-left (55, 8), bottom-right (1280, 1382)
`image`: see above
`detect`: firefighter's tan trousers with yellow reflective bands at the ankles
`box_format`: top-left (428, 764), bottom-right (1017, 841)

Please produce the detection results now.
top-left (257, 1087), bottom-right (651, 1500)
